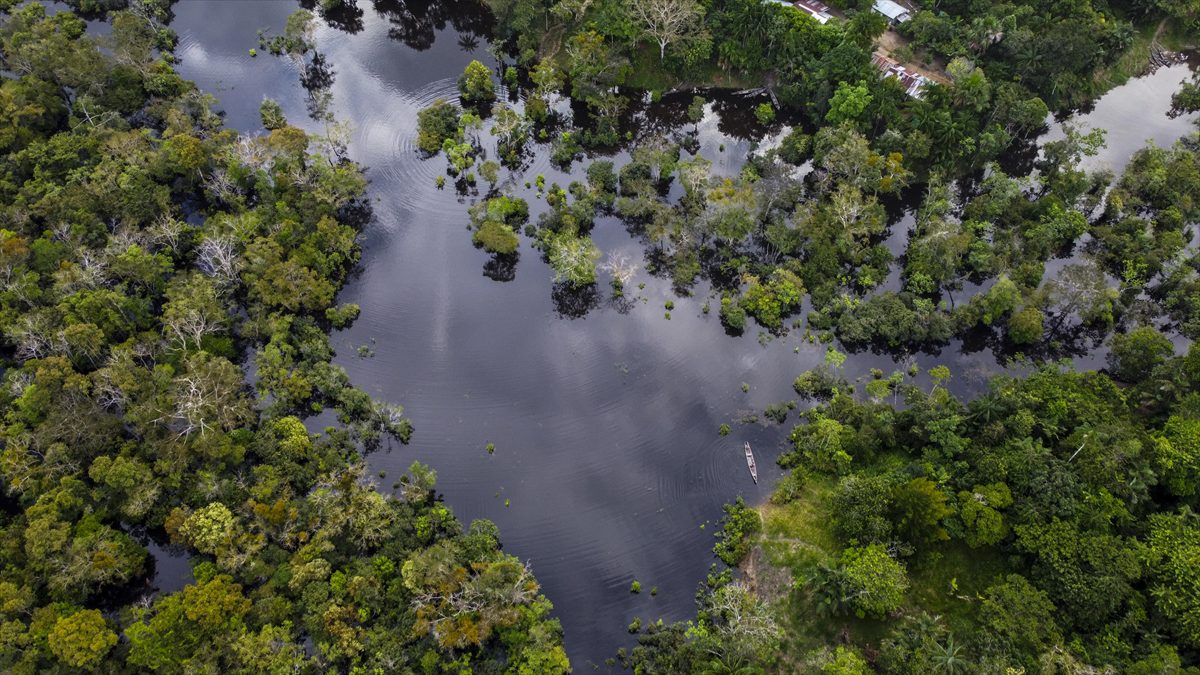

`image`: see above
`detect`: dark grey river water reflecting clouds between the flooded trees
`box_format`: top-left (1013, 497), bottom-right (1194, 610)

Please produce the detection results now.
top-left (162, 0), bottom-right (1192, 671)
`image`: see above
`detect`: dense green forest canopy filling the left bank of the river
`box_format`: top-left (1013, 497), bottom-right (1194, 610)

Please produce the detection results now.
top-left (0, 1), bottom-right (569, 674)
